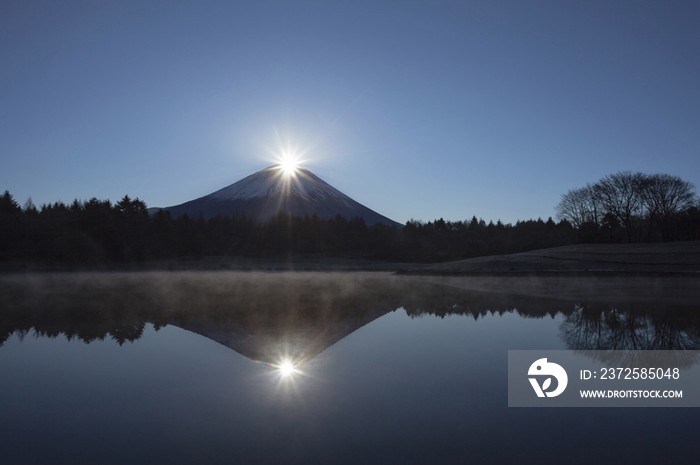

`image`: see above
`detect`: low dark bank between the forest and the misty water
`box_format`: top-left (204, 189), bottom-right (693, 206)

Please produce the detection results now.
top-left (0, 241), bottom-right (700, 277)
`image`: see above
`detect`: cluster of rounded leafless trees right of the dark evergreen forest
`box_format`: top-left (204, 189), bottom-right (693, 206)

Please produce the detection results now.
top-left (556, 171), bottom-right (700, 242)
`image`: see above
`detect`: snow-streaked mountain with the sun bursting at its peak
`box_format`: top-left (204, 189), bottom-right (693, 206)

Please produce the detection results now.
top-left (154, 165), bottom-right (401, 227)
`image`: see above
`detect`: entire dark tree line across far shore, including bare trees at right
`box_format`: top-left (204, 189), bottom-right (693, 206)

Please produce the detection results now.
top-left (0, 172), bottom-right (700, 265)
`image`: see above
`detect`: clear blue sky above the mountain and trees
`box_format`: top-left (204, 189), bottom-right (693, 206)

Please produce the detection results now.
top-left (0, 0), bottom-right (700, 223)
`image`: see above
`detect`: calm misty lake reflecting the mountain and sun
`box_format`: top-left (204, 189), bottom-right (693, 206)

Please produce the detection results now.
top-left (0, 272), bottom-right (700, 464)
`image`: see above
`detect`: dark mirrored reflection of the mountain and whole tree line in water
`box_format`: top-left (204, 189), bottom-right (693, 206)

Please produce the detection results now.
top-left (0, 273), bottom-right (700, 366)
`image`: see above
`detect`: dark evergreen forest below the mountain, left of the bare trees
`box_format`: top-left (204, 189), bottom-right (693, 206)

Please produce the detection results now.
top-left (0, 191), bottom-right (576, 265)
